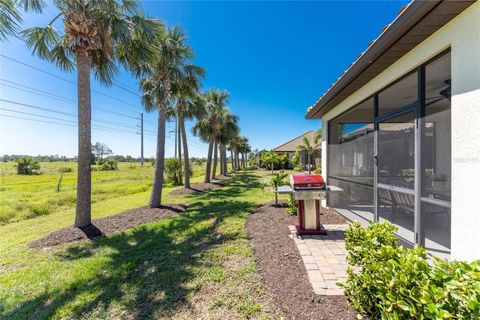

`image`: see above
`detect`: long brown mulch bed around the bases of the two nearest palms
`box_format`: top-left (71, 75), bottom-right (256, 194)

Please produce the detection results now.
top-left (28, 204), bottom-right (187, 249)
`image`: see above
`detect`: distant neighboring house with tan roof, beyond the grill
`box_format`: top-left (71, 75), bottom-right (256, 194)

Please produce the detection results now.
top-left (272, 130), bottom-right (322, 170)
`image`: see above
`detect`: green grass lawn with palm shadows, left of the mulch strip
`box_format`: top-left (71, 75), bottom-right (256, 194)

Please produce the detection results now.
top-left (0, 167), bottom-right (290, 319)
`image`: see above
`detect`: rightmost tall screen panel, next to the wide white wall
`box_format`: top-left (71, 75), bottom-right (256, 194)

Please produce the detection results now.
top-left (420, 53), bottom-right (452, 256)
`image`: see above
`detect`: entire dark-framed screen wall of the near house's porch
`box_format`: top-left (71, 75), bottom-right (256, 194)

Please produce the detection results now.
top-left (327, 51), bottom-right (452, 258)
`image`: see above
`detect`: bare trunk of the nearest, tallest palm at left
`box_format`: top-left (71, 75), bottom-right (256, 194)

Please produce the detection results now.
top-left (75, 50), bottom-right (92, 228)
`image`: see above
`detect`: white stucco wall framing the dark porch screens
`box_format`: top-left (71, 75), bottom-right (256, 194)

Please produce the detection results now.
top-left (322, 2), bottom-right (480, 261)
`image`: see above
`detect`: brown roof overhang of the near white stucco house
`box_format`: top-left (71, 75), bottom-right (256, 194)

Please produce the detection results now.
top-left (306, 0), bottom-right (475, 119)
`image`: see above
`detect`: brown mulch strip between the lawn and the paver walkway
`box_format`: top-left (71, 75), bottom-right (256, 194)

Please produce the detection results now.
top-left (246, 204), bottom-right (356, 320)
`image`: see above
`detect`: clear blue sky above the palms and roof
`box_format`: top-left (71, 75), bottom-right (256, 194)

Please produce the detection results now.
top-left (0, 1), bottom-right (406, 157)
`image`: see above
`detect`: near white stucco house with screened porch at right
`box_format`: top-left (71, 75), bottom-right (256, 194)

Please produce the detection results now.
top-left (307, 1), bottom-right (480, 261)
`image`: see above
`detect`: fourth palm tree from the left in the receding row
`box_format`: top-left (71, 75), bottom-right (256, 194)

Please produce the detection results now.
top-left (192, 89), bottom-right (229, 182)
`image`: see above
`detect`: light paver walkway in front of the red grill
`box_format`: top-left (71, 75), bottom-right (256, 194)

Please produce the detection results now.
top-left (289, 224), bottom-right (347, 295)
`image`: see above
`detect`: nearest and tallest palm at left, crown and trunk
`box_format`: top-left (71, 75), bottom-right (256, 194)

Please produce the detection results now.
top-left (22, 0), bottom-right (160, 227)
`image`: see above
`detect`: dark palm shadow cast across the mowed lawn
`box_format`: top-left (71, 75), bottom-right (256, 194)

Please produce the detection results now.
top-left (6, 201), bottom-right (254, 319)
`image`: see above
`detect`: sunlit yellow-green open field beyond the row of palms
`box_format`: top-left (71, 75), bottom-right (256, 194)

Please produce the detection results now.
top-left (0, 162), bottom-right (208, 225)
